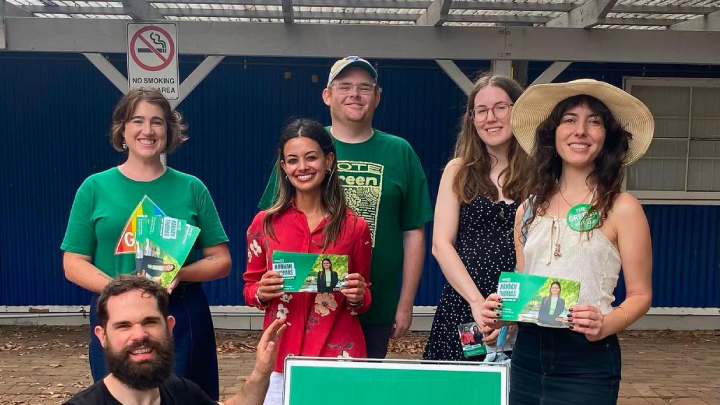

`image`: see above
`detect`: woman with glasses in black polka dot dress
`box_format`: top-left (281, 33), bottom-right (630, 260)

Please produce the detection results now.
top-left (424, 74), bottom-right (527, 360)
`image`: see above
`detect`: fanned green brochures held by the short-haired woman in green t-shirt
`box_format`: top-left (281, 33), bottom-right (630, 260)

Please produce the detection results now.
top-left (135, 215), bottom-right (200, 287)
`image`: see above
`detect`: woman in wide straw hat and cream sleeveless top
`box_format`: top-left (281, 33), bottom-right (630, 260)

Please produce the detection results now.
top-left (483, 80), bottom-right (653, 405)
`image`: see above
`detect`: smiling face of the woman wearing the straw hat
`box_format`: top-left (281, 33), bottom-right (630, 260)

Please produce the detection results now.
top-left (555, 104), bottom-right (606, 167)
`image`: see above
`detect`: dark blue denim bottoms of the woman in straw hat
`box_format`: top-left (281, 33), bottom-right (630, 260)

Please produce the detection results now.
top-left (510, 324), bottom-right (621, 405)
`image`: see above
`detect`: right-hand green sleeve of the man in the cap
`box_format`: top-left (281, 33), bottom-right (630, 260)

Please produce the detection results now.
top-left (400, 145), bottom-right (433, 232)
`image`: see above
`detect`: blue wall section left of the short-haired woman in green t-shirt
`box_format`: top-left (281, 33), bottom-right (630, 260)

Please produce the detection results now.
top-left (0, 53), bottom-right (120, 305)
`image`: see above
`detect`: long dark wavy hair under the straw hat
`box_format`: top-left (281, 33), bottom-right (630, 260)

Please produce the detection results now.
top-left (522, 94), bottom-right (632, 232)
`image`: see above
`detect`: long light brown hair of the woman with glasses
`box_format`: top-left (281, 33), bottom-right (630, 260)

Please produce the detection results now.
top-left (453, 73), bottom-right (527, 204)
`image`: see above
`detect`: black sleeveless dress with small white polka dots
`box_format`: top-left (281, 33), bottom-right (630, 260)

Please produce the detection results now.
top-left (423, 197), bottom-right (518, 361)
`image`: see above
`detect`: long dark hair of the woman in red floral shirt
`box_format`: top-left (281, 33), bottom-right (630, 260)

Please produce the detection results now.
top-left (263, 118), bottom-right (347, 247)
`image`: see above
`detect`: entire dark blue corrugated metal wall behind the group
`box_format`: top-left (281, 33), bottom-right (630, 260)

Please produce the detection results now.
top-left (0, 53), bottom-right (720, 307)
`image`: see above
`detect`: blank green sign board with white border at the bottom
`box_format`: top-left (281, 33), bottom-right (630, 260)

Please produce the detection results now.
top-left (283, 357), bottom-right (509, 405)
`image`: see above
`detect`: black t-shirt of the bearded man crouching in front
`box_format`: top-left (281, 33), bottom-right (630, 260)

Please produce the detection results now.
top-left (65, 374), bottom-right (217, 405)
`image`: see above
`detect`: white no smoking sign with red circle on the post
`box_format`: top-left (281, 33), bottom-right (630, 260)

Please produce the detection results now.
top-left (127, 23), bottom-right (180, 100)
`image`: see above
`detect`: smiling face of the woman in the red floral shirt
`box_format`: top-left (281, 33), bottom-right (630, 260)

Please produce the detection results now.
top-left (280, 136), bottom-right (335, 192)
